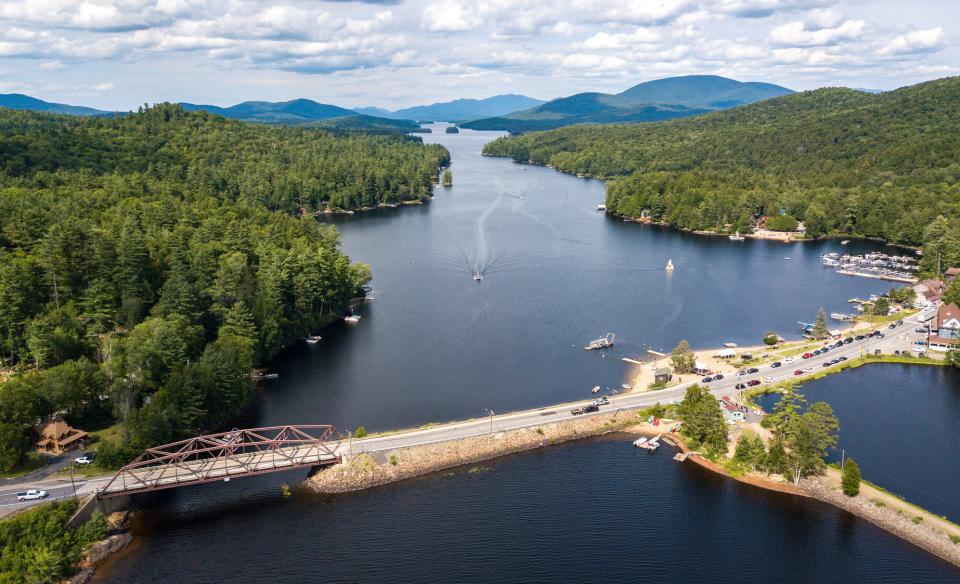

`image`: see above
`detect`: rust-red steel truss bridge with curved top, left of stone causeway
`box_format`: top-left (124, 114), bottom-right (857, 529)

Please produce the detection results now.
top-left (98, 425), bottom-right (339, 498)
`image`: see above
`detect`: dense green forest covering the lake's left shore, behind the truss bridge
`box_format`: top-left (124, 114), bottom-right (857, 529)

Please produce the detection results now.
top-left (0, 105), bottom-right (449, 470)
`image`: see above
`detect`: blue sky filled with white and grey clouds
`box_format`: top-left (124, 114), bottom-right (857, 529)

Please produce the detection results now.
top-left (0, 0), bottom-right (960, 110)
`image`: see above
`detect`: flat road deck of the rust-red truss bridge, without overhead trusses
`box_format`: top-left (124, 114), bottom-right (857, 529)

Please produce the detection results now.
top-left (98, 443), bottom-right (340, 498)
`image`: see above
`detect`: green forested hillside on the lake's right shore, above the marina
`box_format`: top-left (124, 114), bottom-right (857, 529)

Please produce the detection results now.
top-left (484, 77), bottom-right (960, 264)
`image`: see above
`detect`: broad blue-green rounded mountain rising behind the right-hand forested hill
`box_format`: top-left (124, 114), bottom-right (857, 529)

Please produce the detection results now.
top-left (460, 75), bottom-right (793, 134)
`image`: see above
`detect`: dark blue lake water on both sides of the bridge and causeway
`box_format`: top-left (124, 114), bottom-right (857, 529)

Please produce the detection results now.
top-left (98, 125), bottom-right (957, 582)
